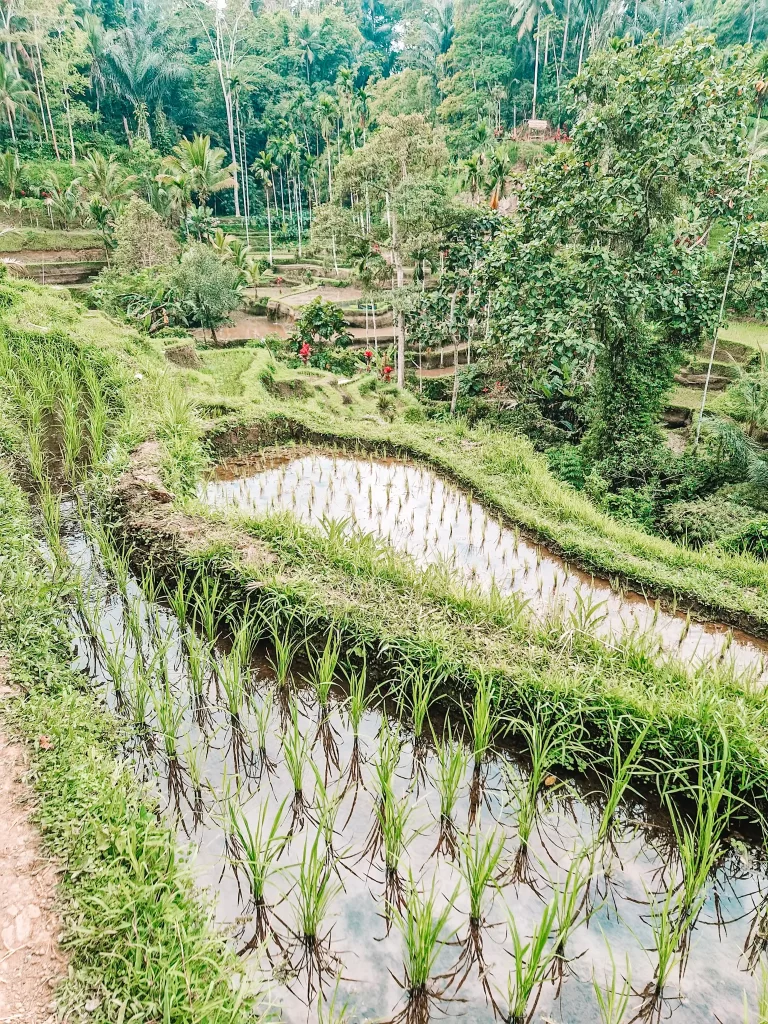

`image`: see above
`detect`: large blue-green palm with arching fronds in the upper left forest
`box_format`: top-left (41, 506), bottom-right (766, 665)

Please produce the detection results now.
top-left (105, 22), bottom-right (189, 141)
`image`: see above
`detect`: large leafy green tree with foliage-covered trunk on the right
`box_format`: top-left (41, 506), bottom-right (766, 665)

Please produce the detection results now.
top-left (488, 32), bottom-right (755, 486)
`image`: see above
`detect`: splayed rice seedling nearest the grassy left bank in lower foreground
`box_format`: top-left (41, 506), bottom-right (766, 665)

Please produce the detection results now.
top-left (231, 798), bottom-right (288, 948)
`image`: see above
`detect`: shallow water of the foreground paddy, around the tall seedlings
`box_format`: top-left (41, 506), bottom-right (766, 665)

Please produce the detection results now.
top-left (68, 507), bottom-right (768, 1024)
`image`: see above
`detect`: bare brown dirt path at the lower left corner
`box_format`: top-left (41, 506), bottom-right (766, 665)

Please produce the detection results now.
top-left (0, 655), bottom-right (67, 1024)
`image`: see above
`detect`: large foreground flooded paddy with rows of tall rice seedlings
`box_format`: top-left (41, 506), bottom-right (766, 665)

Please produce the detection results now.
top-left (62, 491), bottom-right (768, 1024)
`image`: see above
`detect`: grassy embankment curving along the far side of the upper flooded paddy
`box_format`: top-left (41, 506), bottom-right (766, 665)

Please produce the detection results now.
top-left (178, 335), bottom-right (768, 635)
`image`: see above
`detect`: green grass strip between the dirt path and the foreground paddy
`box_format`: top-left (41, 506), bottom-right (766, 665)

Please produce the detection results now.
top-left (0, 471), bottom-right (264, 1024)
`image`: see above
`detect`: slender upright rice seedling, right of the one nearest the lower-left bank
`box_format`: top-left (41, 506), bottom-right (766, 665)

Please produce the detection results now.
top-left (294, 830), bottom-right (341, 995)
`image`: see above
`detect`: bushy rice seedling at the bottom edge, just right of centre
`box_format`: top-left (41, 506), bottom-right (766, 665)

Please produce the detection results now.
top-left (392, 877), bottom-right (458, 1024)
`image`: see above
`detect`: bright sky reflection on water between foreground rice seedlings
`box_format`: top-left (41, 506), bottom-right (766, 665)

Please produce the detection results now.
top-left (64, 505), bottom-right (768, 1024)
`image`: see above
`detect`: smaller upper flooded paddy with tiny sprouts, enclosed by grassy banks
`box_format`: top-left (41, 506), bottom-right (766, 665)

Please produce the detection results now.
top-left (201, 454), bottom-right (768, 675)
